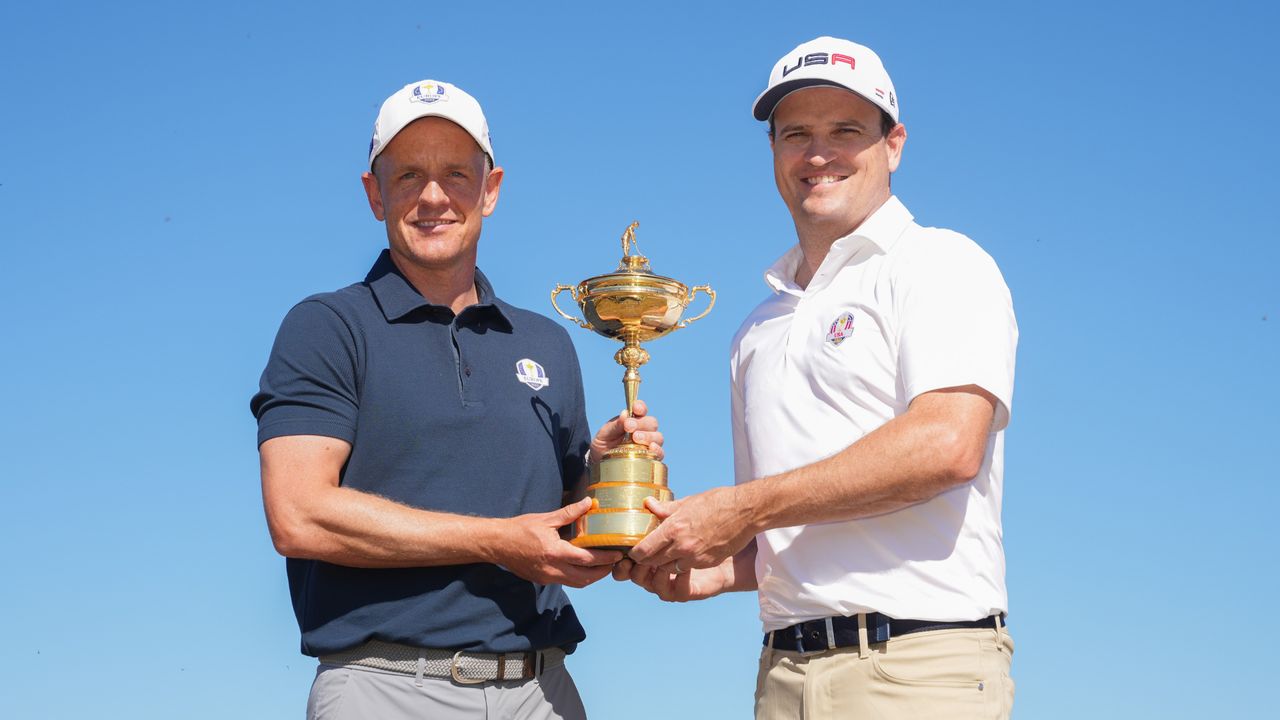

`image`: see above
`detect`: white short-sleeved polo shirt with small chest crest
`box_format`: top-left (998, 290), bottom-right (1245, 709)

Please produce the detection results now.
top-left (731, 197), bottom-right (1018, 632)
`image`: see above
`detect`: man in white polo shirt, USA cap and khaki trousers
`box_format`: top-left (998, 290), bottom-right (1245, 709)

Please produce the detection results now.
top-left (614, 37), bottom-right (1018, 720)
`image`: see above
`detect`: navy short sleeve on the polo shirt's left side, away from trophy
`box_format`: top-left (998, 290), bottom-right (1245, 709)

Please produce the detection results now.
top-left (250, 300), bottom-right (358, 445)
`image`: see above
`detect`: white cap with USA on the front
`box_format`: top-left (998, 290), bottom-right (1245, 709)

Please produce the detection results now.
top-left (751, 36), bottom-right (897, 123)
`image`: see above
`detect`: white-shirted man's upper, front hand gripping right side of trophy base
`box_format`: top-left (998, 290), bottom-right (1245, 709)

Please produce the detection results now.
top-left (631, 487), bottom-right (755, 574)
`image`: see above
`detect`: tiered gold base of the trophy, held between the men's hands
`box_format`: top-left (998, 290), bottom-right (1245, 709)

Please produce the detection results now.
top-left (571, 443), bottom-right (673, 552)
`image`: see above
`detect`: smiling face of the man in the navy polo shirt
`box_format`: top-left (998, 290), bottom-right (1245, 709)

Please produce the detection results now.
top-left (361, 117), bottom-right (502, 279)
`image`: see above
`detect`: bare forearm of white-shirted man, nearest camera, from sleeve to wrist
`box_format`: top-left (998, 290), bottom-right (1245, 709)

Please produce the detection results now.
top-left (735, 386), bottom-right (991, 532)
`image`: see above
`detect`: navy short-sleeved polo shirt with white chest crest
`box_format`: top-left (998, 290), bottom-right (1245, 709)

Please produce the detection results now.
top-left (250, 250), bottom-right (589, 655)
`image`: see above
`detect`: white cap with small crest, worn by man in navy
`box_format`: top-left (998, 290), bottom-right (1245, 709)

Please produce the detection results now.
top-left (369, 79), bottom-right (497, 170)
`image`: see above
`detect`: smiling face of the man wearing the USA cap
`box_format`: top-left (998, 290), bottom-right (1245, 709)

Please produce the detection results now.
top-left (771, 87), bottom-right (906, 245)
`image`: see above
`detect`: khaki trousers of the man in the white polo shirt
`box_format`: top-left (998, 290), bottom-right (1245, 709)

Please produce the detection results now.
top-left (755, 620), bottom-right (1014, 720)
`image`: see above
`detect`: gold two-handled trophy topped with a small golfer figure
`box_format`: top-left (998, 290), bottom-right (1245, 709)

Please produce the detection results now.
top-left (552, 223), bottom-right (716, 552)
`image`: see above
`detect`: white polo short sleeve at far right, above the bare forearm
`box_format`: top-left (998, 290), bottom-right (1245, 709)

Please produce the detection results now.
top-left (893, 231), bottom-right (1018, 432)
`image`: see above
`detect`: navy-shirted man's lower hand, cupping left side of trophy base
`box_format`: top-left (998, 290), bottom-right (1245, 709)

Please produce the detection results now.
top-left (494, 497), bottom-right (622, 588)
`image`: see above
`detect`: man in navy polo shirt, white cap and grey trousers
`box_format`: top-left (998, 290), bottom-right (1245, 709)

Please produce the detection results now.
top-left (251, 81), bottom-right (662, 719)
